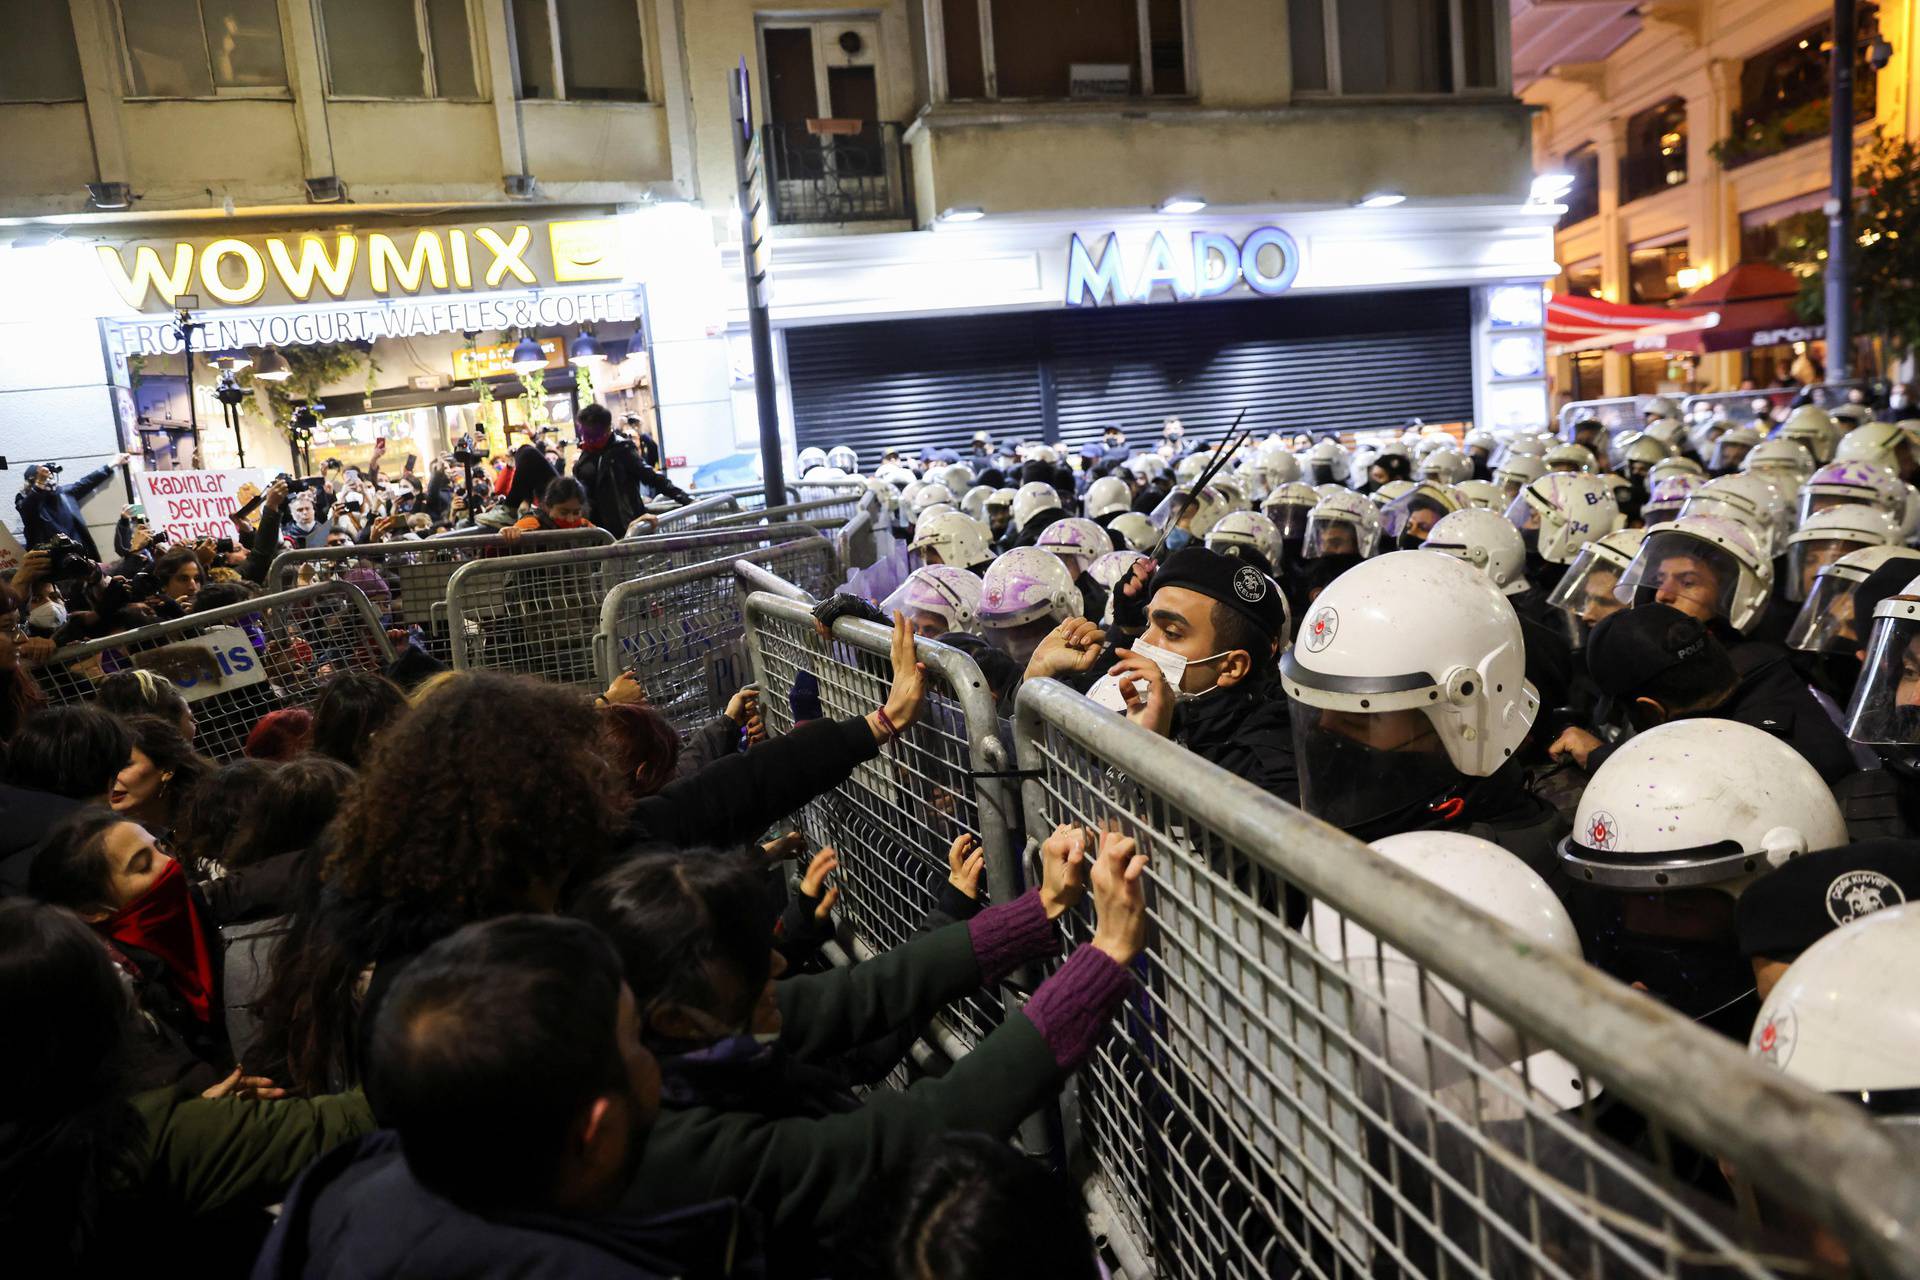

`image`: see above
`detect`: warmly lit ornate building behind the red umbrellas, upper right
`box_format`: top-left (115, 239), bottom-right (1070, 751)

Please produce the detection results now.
top-left (1521, 0), bottom-right (1920, 399)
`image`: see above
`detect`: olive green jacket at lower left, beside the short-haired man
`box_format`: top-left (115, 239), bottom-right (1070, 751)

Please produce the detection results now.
top-left (106, 1090), bottom-right (376, 1217)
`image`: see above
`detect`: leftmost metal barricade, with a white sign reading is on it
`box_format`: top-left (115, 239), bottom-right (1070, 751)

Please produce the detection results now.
top-left (35, 581), bottom-right (394, 760)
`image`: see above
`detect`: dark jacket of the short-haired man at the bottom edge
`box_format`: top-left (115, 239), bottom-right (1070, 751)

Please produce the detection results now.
top-left (253, 1130), bottom-right (760, 1280)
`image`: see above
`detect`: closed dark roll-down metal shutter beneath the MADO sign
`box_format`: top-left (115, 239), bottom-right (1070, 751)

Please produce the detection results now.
top-left (787, 290), bottom-right (1473, 466)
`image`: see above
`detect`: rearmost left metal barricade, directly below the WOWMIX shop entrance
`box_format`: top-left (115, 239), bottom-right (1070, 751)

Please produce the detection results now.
top-left (267, 526), bottom-right (612, 660)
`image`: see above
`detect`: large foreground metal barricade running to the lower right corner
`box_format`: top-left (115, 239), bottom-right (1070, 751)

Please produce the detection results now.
top-left (1006, 679), bottom-right (1920, 1280)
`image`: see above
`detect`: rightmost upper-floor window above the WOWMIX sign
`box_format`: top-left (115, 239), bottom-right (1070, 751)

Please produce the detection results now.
top-left (513, 0), bottom-right (647, 102)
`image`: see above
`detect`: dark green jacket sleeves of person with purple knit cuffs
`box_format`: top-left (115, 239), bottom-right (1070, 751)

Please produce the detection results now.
top-left (628, 923), bottom-right (1062, 1257)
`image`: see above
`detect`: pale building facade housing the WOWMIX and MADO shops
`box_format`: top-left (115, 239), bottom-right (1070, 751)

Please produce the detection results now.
top-left (0, 0), bottom-right (1555, 545)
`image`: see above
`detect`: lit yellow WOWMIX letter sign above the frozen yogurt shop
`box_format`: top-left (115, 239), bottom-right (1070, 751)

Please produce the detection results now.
top-left (96, 219), bottom-right (628, 311)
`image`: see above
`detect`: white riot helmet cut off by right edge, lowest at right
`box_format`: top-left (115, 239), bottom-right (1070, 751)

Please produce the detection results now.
top-left (1747, 902), bottom-right (1920, 1125)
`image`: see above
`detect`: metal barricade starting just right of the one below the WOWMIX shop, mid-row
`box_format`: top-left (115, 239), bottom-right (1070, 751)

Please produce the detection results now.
top-left (445, 524), bottom-right (833, 687)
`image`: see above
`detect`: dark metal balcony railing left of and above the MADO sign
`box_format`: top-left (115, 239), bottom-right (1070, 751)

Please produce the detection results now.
top-left (764, 119), bottom-right (912, 226)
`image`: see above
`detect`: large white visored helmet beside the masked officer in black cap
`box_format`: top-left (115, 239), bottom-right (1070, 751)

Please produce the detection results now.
top-left (1281, 551), bottom-right (1540, 835)
